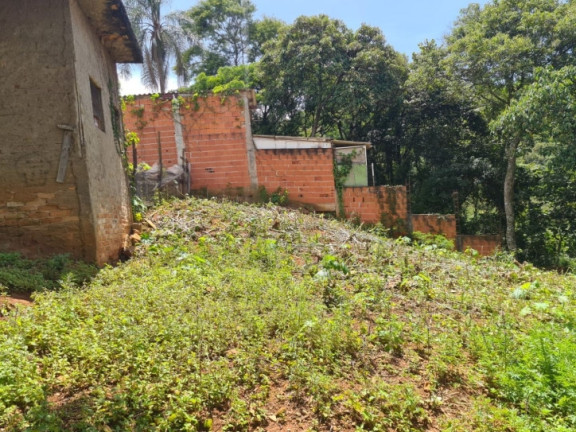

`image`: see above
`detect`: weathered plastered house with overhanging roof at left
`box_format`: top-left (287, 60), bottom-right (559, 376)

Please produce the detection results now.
top-left (0, 0), bottom-right (142, 264)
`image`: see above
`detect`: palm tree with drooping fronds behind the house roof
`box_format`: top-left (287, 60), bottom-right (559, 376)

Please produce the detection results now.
top-left (125, 0), bottom-right (194, 93)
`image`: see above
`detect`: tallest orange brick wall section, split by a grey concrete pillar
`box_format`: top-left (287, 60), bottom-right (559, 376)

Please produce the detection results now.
top-left (124, 96), bottom-right (250, 193)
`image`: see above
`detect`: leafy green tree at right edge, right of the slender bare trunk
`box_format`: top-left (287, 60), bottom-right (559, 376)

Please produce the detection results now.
top-left (493, 66), bottom-right (576, 266)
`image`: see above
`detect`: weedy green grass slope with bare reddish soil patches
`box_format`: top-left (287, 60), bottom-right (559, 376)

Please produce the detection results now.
top-left (0, 199), bottom-right (576, 431)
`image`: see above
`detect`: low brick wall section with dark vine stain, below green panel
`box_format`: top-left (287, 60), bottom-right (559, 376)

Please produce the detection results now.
top-left (343, 186), bottom-right (408, 235)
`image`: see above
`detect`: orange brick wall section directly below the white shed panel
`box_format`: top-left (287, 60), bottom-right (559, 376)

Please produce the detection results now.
top-left (256, 149), bottom-right (336, 211)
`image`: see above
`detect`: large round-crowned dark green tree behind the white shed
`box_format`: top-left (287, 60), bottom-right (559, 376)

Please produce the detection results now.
top-left (257, 15), bottom-right (407, 146)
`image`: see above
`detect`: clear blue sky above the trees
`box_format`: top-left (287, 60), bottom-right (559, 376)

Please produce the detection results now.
top-left (122, 0), bottom-right (487, 94)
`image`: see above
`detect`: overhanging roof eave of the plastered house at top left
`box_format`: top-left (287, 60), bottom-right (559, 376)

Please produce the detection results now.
top-left (78, 0), bottom-right (142, 63)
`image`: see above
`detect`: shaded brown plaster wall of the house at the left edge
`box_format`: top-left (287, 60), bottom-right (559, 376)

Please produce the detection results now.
top-left (0, 0), bottom-right (84, 257)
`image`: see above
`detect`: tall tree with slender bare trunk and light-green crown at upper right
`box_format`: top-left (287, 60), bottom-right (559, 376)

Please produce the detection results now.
top-left (447, 0), bottom-right (574, 250)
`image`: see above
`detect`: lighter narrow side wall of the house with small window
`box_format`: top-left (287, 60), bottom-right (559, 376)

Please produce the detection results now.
top-left (70, 0), bottom-right (131, 263)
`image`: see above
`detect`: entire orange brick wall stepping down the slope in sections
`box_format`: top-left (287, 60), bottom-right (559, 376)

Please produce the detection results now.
top-left (124, 96), bottom-right (480, 248)
